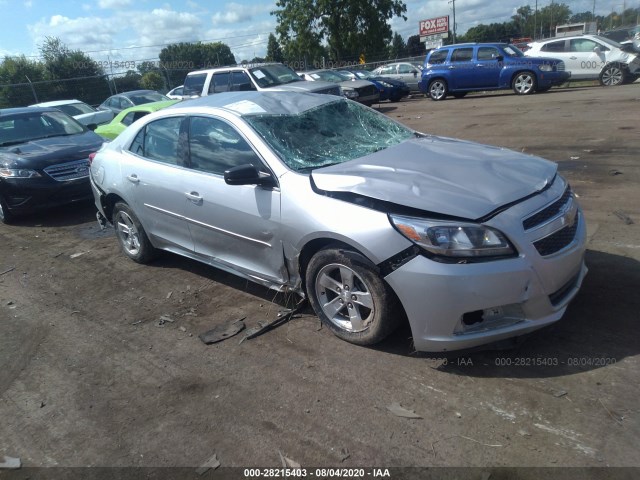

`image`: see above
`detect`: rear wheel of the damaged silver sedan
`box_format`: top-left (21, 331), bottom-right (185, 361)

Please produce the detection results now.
top-left (113, 202), bottom-right (157, 263)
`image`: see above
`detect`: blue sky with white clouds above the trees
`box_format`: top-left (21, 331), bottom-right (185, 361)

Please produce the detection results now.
top-left (0, 0), bottom-right (640, 63)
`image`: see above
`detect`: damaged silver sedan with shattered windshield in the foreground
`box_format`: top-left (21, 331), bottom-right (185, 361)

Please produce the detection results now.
top-left (91, 92), bottom-right (587, 351)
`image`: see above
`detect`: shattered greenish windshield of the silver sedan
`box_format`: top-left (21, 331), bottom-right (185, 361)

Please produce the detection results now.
top-left (245, 100), bottom-right (414, 170)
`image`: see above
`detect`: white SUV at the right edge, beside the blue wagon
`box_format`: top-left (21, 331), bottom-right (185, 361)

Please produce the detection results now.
top-left (525, 35), bottom-right (640, 86)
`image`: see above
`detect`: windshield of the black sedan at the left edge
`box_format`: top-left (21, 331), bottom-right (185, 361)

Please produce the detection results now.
top-left (0, 112), bottom-right (85, 147)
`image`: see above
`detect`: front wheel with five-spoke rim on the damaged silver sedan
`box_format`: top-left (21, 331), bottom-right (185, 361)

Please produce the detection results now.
top-left (305, 248), bottom-right (402, 345)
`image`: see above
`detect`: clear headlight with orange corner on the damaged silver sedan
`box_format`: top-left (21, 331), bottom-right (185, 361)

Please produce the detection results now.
top-left (389, 215), bottom-right (516, 258)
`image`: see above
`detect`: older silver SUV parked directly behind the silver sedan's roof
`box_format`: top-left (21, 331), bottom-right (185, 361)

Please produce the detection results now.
top-left (183, 63), bottom-right (341, 97)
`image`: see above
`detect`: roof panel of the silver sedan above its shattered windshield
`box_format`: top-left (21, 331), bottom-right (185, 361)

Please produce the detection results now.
top-left (168, 91), bottom-right (346, 116)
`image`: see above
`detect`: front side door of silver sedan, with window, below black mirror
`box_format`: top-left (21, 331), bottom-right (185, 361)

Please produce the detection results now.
top-left (184, 116), bottom-right (286, 283)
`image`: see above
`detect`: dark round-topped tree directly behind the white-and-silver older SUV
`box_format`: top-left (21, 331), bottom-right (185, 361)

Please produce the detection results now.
top-left (160, 42), bottom-right (236, 87)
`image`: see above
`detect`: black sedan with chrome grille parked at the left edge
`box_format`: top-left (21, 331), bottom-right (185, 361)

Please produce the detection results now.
top-left (0, 107), bottom-right (103, 223)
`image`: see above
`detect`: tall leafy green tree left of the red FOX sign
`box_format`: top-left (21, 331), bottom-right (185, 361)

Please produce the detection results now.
top-left (271, 0), bottom-right (407, 62)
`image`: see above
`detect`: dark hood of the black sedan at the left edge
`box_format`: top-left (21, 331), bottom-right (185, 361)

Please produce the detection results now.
top-left (0, 131), bottom-right (104, 169)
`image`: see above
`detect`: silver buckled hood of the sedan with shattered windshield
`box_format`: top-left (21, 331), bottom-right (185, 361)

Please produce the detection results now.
top-left (311, 136), bottom-right (557, 218)
